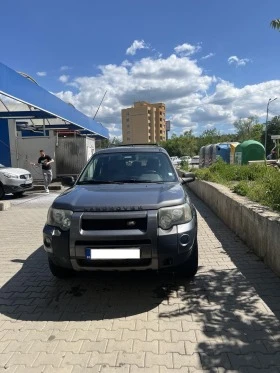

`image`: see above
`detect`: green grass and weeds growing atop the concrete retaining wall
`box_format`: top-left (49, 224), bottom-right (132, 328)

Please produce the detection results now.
top-left (183, 161), bottom-right (280, 212)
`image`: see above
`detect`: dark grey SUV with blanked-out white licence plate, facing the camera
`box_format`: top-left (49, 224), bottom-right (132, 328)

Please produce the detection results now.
top-left (43, 145), bottom-right (198, 278)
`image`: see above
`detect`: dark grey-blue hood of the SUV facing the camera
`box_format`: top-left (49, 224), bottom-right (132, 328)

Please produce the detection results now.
top-left (52, 182), bottom-right (187, 211)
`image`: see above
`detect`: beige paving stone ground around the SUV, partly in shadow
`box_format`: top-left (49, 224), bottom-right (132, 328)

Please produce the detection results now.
top-left (0, 193), bottom-right (280, 373)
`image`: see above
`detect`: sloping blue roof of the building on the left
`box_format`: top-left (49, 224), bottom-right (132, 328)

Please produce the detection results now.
top-left (0, 63), bottom-right (109, 139)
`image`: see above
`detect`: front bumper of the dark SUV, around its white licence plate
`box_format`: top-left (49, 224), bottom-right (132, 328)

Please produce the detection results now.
top-left (43, 211), bottom-right (197, 271)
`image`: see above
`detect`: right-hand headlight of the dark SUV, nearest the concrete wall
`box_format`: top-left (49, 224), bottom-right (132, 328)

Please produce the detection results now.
top-left (158, 203), bottom-right (193, 229)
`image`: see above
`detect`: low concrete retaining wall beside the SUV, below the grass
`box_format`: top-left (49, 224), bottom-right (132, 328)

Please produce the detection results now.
top-left (188, 180), bottom-right (280, 275)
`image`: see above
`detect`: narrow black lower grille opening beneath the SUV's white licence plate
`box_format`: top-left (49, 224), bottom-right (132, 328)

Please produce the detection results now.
top-left (77, 258), bottom-right (152, 268)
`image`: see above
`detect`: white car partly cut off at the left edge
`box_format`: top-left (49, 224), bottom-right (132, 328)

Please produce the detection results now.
top-left (0, 163), bottom-right (33, 199)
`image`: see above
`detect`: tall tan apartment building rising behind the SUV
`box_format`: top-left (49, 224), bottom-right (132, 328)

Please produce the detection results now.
top-left (122, 101), bottom-right (166, 144)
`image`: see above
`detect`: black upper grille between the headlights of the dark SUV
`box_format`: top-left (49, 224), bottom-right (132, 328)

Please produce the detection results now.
top-left (81, 217), bottom-right (147, 232)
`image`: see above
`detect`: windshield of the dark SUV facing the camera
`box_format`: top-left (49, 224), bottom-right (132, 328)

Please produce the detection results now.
top-left (77, 152), bottom-right (178, 184)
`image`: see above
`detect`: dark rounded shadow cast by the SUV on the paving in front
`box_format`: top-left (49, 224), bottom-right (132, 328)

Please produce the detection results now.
top-left (0, 247), bottom-right (190, 321)
